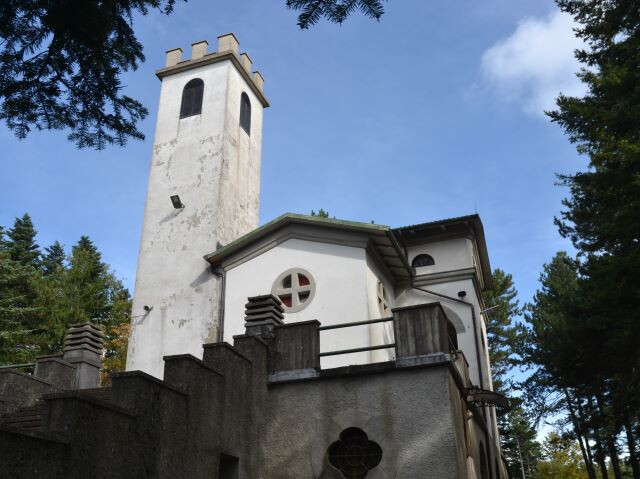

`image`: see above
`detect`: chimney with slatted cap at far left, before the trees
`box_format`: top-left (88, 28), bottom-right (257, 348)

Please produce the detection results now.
top-left (62, 323), bottom-right (104, 389)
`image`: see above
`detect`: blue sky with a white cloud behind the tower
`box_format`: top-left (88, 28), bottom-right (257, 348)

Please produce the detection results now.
top-left (0, 0), bottom-right (586, 308)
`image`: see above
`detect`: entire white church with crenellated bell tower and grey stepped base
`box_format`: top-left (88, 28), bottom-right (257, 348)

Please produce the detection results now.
top-left (0, 34), bottom-right (508, 479)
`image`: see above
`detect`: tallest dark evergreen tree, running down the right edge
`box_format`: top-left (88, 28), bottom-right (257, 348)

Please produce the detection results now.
top-left (549, 0), bottom-right (640, 422)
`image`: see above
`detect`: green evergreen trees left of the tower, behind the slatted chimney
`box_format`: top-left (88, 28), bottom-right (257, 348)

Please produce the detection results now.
top-left (0, 215), bottom-right (131, 379)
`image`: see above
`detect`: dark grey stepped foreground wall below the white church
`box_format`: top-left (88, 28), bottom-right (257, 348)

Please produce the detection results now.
top-left (0, 297), bottom-right (504, 479)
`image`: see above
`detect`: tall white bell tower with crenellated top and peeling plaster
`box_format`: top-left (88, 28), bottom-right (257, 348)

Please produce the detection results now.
top-left (127, 34), bottom-right (269, 377)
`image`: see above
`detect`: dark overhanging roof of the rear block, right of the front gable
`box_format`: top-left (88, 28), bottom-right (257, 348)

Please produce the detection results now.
top-left (392, 214), bottom-right (492, 289)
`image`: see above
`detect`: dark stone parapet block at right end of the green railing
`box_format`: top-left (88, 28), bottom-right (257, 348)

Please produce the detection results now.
top-left (393, 303), bottom-right (450, 359)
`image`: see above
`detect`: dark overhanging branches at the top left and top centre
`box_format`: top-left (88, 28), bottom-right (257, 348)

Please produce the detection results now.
top-left (0, 0), bottom-right (384, 149)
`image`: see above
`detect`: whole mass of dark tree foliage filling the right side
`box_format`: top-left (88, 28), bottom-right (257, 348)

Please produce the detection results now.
top-left (523, 0), bottom-right (640, 479)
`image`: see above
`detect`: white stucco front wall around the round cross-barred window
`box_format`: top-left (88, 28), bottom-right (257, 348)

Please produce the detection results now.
top-left (224, 239), bottom-right (390, 368)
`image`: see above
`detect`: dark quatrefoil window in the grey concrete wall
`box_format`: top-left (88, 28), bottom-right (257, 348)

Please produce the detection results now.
top-left (328, 427), bottom-right (382, 479)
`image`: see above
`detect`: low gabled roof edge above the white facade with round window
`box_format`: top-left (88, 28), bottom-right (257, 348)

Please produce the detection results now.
top-left (204, 213), bottom-right (413, 279)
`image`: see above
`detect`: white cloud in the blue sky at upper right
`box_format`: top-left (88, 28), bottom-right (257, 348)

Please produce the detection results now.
top-left (482, 10), bottom-right (585, 114)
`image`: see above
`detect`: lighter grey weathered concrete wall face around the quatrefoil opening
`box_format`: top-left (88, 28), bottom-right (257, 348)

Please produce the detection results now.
top-left (266, 366), bottom-right (466, 479)
